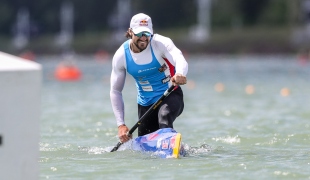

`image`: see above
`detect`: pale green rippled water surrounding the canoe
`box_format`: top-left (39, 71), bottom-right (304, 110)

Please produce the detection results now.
top-left (38, 56), bottom-right (310, 179)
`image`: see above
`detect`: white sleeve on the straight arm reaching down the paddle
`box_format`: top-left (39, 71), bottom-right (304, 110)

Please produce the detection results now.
top-left (110, 45), bottom-right (126, 126)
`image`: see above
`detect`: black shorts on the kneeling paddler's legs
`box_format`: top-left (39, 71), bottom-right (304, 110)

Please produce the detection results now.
top-left (138, 87), bottom-right (184, 136)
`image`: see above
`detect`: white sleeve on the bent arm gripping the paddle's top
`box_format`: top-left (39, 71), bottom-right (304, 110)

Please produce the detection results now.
top-left (153, 34), bottom-right (188, 76)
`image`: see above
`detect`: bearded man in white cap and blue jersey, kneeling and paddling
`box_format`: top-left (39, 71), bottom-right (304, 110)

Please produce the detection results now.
top-left (110, 13), bottom-right (188, 143)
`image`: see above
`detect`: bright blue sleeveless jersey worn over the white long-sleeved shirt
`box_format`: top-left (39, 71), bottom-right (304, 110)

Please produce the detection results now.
top-left (124, 40), bottom-right (171, 106)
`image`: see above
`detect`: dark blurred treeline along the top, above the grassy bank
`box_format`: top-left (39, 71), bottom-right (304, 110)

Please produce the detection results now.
top-left (0, 0), bottom-right (302, 35)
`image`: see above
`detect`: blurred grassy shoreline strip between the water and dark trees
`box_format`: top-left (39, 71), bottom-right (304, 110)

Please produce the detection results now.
top-left (0, 27), bottom-right (310, 55)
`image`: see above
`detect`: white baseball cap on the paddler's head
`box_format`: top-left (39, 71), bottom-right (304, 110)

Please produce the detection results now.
top-left (130, 13), bottom-right (153, 34)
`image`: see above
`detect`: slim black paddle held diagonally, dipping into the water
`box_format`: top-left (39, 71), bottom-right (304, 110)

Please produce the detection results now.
top-left (111, 85), bottom-right (177, 152)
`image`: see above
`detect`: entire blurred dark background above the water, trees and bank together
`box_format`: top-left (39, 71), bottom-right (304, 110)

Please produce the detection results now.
top-left (0, 0), bottom-right (310, 54)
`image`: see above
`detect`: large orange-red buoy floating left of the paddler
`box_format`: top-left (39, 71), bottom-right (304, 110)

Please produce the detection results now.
top-left (55, 63), bottom-right (82, 81)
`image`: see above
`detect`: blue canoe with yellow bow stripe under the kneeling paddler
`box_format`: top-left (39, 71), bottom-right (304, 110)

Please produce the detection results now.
top-left (132, 128), bottom-right (185, 158)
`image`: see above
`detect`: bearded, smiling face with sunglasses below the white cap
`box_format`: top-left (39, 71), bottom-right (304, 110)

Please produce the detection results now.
top-left (131, 32), bottom-right (151, 52)
